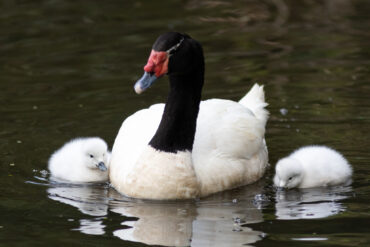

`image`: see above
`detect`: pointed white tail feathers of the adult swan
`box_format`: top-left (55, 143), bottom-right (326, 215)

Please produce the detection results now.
top-left (239, 83), bottom-right (269, 125)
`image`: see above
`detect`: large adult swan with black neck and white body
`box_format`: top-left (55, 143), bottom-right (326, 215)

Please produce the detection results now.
top-left (109, 32), bottom-right (268, 200)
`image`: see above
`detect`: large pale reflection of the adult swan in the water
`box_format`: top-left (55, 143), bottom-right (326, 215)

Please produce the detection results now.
top-left (110, 180), bottom-right (263, 246)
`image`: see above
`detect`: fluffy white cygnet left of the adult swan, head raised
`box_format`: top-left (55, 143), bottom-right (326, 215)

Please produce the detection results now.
top-left (48, 137), bottom-right (110, 183)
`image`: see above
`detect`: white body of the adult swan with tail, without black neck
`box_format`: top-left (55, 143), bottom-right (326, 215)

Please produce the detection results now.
top-left (109, 84), bottom-right (268, 199)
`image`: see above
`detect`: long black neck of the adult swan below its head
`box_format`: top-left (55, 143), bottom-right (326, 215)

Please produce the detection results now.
top-left (149, 67), bottom-right (204, 153)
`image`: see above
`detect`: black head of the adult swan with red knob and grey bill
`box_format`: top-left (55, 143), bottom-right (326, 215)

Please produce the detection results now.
top-left (134, 32), bottom-right (204, 94)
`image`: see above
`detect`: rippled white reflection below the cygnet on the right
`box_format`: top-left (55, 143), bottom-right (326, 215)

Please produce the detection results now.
top-left (275, 186), bottom-right (352, 220)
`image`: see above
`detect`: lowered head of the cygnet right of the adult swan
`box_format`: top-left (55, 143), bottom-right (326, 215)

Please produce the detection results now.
top-left (274, 157), bottom-right (303, 189)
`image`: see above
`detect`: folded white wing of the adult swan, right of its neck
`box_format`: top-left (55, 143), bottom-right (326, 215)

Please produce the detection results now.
top-left (193, 99), bottom-right (268, 196)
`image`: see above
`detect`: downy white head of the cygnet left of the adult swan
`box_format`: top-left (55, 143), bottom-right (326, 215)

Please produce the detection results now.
top-left (82, 137), bottom-right (109, 172)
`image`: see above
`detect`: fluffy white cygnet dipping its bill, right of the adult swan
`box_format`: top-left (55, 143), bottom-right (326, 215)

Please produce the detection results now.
top-left (274, 146), bottom-right (352, 189)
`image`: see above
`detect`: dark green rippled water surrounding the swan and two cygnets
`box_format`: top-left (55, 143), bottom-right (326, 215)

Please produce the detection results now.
top-left (0, 0), bottom-right (370, 246)
